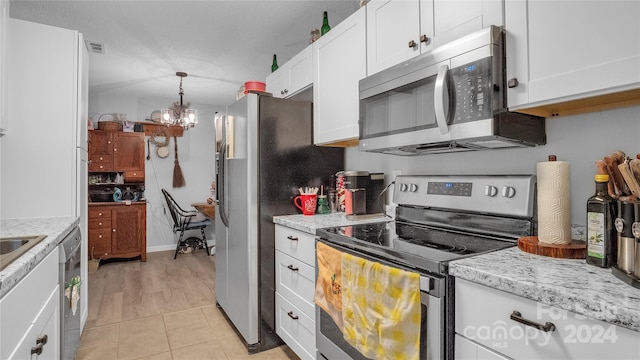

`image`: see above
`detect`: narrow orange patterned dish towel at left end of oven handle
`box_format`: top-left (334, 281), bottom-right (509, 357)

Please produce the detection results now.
top-left (315, 242), bottom-right (342, 331)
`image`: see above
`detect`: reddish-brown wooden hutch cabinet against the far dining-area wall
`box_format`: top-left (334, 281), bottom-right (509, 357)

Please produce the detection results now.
top-left (88, 130), bottom-right (147, 261)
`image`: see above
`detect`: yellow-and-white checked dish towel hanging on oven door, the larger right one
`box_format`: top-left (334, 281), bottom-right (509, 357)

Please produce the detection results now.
top-left (342, 253), bottom-right (420, 360)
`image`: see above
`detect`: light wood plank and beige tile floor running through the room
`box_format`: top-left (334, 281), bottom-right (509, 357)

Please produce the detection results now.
top-left (76, 250), bottom-right (298, 360)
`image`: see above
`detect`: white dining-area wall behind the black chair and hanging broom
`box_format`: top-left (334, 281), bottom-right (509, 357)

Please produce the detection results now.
top-left (89, 93), bottom-right (224, 252)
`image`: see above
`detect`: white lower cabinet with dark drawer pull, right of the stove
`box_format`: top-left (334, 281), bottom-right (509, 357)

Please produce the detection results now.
top-left (455, 279), bottom-right (640, 360)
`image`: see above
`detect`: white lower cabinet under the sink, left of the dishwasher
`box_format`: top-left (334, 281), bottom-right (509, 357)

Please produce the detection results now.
top-left (0, 248), bottom-right (60, 360)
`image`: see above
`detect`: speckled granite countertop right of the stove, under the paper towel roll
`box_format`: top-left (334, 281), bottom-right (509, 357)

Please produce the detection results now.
top-left (449, 247), bottom-right (640, 332)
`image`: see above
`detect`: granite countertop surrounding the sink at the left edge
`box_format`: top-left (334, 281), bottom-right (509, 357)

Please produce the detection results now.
top-left (0, 217), bottom-right (80, 298)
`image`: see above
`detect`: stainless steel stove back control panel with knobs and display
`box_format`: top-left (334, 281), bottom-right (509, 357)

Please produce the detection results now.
top-left (393, 175), bottom-right (536, 217)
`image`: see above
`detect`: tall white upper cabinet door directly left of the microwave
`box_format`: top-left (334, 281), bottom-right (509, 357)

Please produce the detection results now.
top-left (313, 7), bottom-right (367, 144)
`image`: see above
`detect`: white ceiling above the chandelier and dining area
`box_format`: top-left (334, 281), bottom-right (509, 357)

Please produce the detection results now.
top-left (8, 0), bottom-right (359, 106)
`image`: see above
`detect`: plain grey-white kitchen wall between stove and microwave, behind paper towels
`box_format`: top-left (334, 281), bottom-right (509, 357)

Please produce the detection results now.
top-left (345, 106), bottom-right (640, 226)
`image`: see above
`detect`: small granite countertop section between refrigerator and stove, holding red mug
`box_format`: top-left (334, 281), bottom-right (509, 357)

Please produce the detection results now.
top-left (273, 213), bottom-right (391, 235)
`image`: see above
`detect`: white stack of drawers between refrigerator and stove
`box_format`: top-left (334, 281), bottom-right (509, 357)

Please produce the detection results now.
top-left (275, 225), bottom-right (316, 359)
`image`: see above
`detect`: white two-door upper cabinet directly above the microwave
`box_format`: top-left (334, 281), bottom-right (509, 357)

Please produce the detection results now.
top-left (367, 0), bottom-right (504, 75)
